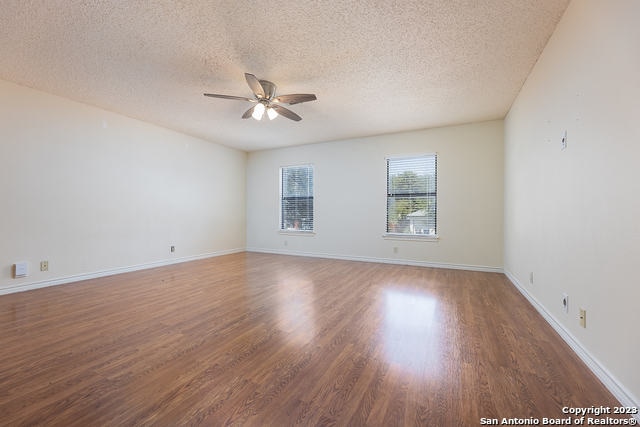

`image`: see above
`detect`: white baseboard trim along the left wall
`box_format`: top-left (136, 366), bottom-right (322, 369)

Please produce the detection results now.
top-left (0, 248), bottom-right (245, 295)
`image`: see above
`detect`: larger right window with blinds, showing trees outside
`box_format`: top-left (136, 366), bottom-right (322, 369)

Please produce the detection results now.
top-left (387, 154), bottom-right (437, 236)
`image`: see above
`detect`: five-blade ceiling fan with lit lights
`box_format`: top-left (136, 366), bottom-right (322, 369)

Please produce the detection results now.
top-left (204, 73), bottom-right (317, 122)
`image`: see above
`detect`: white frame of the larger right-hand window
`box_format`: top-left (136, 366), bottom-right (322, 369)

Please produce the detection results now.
top-left (383, 152), bottom-right (439, 242)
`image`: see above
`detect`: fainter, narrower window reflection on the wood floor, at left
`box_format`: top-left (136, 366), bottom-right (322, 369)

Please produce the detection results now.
top-left (277, 278), bottom-right (316, 345)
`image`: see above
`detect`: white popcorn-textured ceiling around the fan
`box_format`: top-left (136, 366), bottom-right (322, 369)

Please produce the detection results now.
top-left (0, 0), bottom-right (568, 151)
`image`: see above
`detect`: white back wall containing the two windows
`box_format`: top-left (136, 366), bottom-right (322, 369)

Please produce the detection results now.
top-left (247, 120), bottom-right (503, 271)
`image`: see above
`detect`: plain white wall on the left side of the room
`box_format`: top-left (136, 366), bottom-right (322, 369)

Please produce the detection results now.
top-left (0, 81), bottom-right (246, 293)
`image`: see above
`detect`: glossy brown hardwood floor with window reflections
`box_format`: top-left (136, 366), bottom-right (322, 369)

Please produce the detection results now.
top-left (0, 253), bottom-right (619, 426)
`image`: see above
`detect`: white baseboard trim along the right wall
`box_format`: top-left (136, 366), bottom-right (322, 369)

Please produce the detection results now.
top-left (504, 269), bottom-right (640, 421)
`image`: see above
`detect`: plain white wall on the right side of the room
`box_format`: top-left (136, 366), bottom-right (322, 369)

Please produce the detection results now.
top-left (505, 0), bottom-right (640, 405)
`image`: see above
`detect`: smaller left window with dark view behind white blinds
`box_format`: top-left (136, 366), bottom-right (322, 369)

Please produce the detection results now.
top-left (280, 165), bottom-right (313, 231)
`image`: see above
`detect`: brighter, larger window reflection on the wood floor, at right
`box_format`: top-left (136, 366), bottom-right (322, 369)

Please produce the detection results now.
top-left (384, 289), bottom-right (440, 374)
